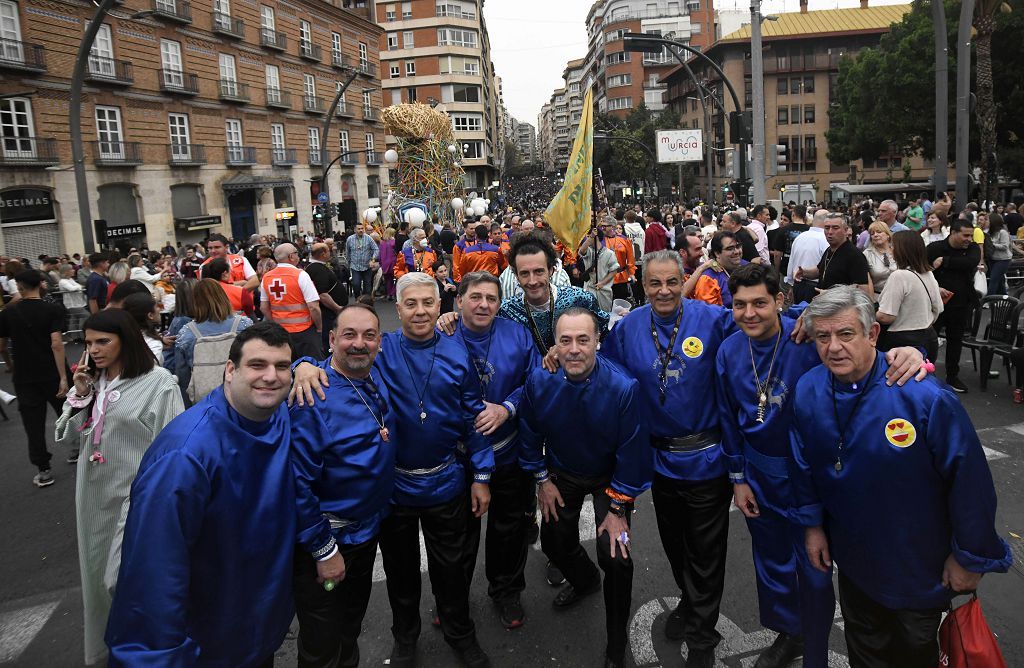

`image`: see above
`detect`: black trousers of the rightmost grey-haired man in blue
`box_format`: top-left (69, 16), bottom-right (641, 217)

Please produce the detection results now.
top-left (839, 570), bottom-right (944, 668)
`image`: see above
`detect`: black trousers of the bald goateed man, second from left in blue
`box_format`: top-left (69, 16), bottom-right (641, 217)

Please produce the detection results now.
top-left (292, 537), bottom-right (377, 668)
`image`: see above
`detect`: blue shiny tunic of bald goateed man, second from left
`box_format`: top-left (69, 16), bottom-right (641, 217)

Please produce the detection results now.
top-left (291, 358), bottom-right (395, 557)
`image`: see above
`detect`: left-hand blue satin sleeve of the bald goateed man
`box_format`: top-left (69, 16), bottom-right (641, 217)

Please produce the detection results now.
top-left (290, 406), bottom-right (335, 554)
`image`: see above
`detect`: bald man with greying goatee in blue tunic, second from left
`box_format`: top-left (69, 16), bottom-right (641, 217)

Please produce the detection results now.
top-left (291, 303), bottom-right (395, 668)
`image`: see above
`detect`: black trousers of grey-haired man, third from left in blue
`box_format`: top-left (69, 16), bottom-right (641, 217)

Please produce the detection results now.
top-left (380, 494), bottom-right (476, 650)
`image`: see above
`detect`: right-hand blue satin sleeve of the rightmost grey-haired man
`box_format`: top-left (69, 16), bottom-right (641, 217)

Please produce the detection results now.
top-left (928, 390), bottom-right (1013, 573)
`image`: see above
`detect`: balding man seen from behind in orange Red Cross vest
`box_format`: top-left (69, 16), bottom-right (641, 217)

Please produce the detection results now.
top-left (259, 244), bottom-right (324, 361)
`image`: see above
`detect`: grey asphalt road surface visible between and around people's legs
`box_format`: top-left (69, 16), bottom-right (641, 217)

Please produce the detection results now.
top-left (0, 306), bottom-right (1024, 668)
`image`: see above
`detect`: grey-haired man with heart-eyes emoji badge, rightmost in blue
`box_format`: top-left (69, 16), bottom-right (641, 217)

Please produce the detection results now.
top-left (791, 286), bottom-right (1012, 666)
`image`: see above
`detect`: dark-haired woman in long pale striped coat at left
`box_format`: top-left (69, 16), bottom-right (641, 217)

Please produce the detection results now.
top-left (55, 308), bottom-right (184, 664)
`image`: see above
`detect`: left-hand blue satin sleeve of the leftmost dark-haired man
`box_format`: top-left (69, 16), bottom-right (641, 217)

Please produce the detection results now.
top-left (105, 451), bottom-right (211, 667)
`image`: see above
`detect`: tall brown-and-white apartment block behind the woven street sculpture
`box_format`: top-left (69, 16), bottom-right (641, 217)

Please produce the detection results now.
top-left (375, 0), bottom-right (503, 191)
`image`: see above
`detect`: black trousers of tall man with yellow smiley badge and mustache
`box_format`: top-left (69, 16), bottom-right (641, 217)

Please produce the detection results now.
top-left (651, 473), bottom-right (732, 650)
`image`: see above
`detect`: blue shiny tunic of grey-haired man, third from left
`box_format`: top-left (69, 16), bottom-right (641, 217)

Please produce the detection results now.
top-left (374, 332), bottom-right (495, 506)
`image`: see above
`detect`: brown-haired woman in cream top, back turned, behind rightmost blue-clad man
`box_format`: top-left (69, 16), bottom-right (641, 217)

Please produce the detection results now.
top-left (874, 229), bottom-right (942, 360)
